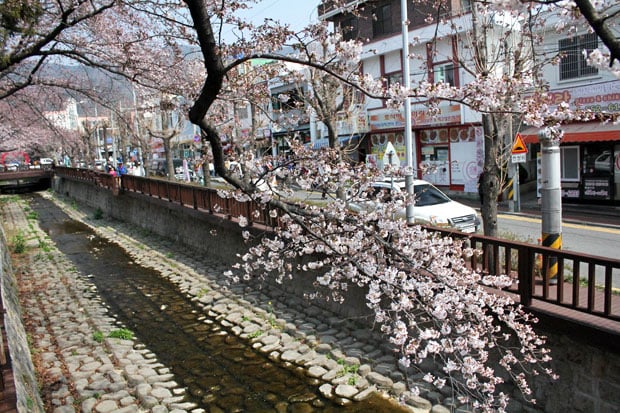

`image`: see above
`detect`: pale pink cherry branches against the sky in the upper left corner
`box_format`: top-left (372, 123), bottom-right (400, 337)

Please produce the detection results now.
top-left (0, 0), bottom-right (196, 156)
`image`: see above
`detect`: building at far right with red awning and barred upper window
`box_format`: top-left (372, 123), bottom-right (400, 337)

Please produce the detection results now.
top-left (522, 12), bottom-right (620, 204)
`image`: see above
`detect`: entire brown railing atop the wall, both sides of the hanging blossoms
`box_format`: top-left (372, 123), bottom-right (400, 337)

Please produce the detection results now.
top-left (56, 167), bottom-right (620, 322)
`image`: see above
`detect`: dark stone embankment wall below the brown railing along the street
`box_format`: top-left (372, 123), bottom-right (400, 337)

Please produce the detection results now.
top-left (53, 177), bottom-right (620, 413)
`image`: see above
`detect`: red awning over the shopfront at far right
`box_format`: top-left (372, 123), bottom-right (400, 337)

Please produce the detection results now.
top-left (520, 122), bottom-right (620, 143)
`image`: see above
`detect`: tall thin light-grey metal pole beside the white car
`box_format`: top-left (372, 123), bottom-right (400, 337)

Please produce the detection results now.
top-left (400, 0), bottom-right (415, 225)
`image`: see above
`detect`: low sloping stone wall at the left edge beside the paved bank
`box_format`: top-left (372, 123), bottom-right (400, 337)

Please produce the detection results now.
top-left (0, 209), bottom-right (45, 413)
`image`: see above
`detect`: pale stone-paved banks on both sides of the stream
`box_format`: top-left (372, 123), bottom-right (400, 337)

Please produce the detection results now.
top-left (3, 193), bottom-right (480, 413)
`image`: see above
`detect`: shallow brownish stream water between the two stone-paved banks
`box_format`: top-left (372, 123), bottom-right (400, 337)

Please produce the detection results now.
top-left (31, 196), bottom-right (405, 413)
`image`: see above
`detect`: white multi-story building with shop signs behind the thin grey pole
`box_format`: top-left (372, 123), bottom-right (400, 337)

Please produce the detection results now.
top-left (319, 0), bottom-right (484, 192)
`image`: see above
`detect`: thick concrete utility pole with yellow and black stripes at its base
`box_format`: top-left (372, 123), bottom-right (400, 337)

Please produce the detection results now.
top-left (538, 132), bottom-right (562, 284)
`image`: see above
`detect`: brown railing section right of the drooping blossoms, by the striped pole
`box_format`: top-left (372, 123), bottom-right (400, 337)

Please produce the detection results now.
top-left (433, 228), bottom-right (620, 321)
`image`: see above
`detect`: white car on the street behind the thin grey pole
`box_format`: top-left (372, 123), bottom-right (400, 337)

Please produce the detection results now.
top-left (351, 179), bottom-right (481, 233)
